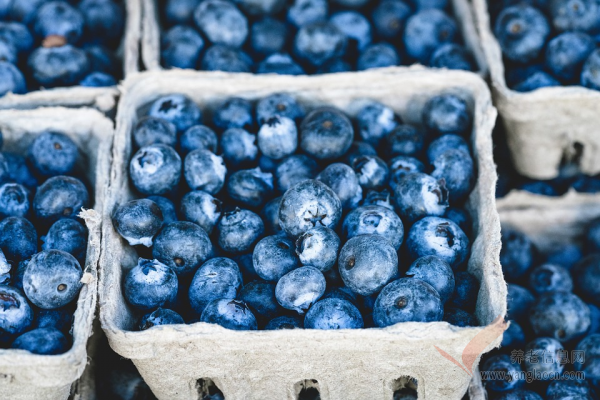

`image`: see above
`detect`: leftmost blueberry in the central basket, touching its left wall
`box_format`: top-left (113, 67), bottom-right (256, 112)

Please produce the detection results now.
top-left (112, 199), bottom-right (164, 247)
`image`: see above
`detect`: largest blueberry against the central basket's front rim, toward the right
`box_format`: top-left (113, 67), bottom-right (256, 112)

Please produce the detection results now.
top-left (373, 278), bottom-right (444, 328)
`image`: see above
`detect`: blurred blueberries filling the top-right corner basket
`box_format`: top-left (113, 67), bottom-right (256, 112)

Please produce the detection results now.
top-left (489, 0), bottom-right (600, 92)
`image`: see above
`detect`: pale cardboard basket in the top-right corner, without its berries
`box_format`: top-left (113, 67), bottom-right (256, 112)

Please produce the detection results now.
top-left (473, 0), bottom-right (600, 179)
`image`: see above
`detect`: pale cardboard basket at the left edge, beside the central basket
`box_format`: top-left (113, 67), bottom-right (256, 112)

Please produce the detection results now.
top-left (0, 107), bottom-right (114, 400)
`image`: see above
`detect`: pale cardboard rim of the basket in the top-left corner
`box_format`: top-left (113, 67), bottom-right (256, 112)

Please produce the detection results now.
top-left (0, 0), bottom-right (142, 113)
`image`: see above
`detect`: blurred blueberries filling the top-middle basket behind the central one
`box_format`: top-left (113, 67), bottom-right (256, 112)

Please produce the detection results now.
top-left (161, 0), bottom-right (475, 75)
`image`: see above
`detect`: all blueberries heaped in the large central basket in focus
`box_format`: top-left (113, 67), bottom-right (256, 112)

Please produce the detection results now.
top-left (112, 93), bottom-right (479, 330)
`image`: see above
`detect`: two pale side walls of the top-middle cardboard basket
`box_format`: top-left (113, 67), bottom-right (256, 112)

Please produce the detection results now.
top-left (141, 0), bottom-right (487, 76)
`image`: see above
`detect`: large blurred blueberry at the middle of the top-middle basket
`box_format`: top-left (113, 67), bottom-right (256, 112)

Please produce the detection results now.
top-left (294, 22), bottom-right (347, 67)
